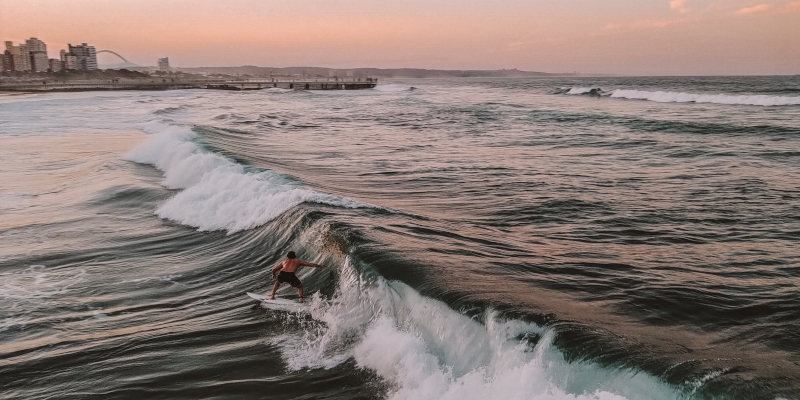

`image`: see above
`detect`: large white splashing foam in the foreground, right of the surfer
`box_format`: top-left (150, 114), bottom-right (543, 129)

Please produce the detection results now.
top-left (273, 257), bottom-right (680, 400)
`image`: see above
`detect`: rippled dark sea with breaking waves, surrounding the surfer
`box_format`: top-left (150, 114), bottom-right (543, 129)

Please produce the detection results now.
top-left (0, 76), bottom-right (800, 400)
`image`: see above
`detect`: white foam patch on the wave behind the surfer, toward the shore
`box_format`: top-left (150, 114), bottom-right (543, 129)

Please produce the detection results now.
top-left (125, 123), bottom-right (370, 233)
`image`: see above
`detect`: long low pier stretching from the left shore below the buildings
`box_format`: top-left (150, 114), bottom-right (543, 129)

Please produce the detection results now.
top-left (0, 77), bottom-right (378, 92)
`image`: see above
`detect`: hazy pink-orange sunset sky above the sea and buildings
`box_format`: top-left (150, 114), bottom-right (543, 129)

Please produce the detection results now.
top-left (0, 0), bottom-right (800, 75)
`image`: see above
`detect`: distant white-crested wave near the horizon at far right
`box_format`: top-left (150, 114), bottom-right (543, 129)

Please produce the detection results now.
top-left (556, 87), bottom-right (800, 106)
